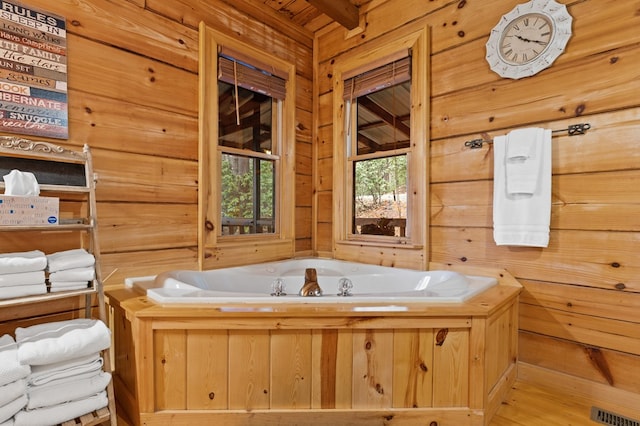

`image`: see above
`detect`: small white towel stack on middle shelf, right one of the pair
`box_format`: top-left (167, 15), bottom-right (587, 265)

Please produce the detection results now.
top-left (47, 249), bottom-right (96, 293)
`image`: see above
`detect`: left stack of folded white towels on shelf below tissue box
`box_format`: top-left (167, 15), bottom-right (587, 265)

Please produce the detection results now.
top-left (0, 250), bottom-right (47, 299)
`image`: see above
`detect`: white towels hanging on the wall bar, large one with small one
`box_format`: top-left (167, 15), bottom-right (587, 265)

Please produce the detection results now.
top-left (493, 128), bottom-right (551, 247)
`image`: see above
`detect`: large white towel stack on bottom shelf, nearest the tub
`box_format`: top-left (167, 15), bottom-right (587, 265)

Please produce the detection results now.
top-left (7, 318), bottom-right (111, 426)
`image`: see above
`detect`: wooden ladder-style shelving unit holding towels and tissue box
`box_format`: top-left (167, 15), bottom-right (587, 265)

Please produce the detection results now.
top-left (0, 136), bottom-right (117, 426)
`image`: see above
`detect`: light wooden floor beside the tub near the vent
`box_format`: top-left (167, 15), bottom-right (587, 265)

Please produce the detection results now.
top-left (111, 381), bottom-right (602, 426)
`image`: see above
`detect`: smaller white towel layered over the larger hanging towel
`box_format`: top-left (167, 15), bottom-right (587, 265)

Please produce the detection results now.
top-left (505, 127), bottom-right (551, 194)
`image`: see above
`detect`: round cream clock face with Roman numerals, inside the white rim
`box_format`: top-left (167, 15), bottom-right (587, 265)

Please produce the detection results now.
top-left (498, 13), bottom-right (553, 65)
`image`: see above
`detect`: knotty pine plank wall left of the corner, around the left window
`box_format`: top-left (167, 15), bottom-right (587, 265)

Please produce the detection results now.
top-left (0, 0), bottom-right (313, 286)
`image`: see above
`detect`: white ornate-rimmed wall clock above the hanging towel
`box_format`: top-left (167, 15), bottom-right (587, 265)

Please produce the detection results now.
top-left (486, 0), bottom-right (572, 79)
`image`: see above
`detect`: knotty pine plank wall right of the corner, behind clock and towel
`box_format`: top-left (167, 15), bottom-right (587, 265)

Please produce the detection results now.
top-left (314, 0), bottom-right (640, 405)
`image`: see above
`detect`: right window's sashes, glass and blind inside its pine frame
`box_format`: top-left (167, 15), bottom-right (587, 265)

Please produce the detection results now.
top-left (344, 56), bottom-right (411, 238)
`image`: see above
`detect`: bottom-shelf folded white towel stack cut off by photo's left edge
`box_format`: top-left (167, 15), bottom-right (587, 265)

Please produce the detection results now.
top-left (0, 334), bottom-right (31, 425)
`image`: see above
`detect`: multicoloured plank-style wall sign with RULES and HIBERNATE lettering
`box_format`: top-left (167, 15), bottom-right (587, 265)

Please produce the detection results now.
top-left (0, 0), bottom-right (69, 139)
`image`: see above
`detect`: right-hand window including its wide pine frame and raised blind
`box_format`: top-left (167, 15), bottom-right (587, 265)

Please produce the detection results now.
top-left (333, 27), bottom-right (429, 269)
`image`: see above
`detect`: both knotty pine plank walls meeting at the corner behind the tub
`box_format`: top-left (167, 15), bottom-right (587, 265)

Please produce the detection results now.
top-left (1, 0), bottom-right (640, 414)
